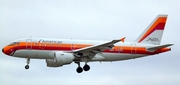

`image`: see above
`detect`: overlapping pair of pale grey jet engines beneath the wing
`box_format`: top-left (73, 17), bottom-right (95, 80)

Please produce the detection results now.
top-left (46, 52), bottom-right (75, 67)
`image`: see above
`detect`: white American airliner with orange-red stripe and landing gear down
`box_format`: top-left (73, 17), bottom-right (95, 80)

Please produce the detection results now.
top-left (2, 15), bottom-right (173, 73)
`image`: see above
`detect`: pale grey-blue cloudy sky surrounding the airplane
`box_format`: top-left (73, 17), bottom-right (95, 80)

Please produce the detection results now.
top-left (0, 0), bottom-right (180, 85)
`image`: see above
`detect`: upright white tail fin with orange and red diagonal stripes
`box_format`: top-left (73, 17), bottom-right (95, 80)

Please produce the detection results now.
top-left (135, 15), bottom-right (167, 45)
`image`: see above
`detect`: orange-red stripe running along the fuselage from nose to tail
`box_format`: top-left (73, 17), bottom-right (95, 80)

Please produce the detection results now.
top-left (4, 42), bottom-right (170, 55)
